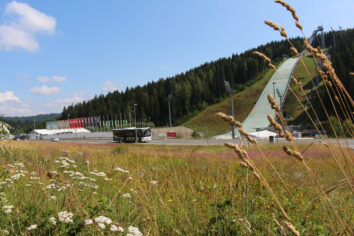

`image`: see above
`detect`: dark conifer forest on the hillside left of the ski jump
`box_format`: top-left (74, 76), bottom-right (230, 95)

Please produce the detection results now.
top-left (61, 38), bottom-right (302, 126)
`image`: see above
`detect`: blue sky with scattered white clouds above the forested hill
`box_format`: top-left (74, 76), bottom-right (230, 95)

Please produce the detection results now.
top-left (0, 0), bottom-right (354, 116)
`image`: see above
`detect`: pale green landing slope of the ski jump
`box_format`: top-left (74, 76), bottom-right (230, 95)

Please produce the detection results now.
top-left (215, 58), bottom-right (299, 139)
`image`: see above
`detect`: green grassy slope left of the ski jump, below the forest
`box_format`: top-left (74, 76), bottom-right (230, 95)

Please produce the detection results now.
top-left (184, 69), bottom-right (274, 136)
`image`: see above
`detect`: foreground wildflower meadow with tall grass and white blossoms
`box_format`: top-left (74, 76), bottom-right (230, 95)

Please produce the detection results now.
top-left (0, 141), bottom-right (354, 235)
